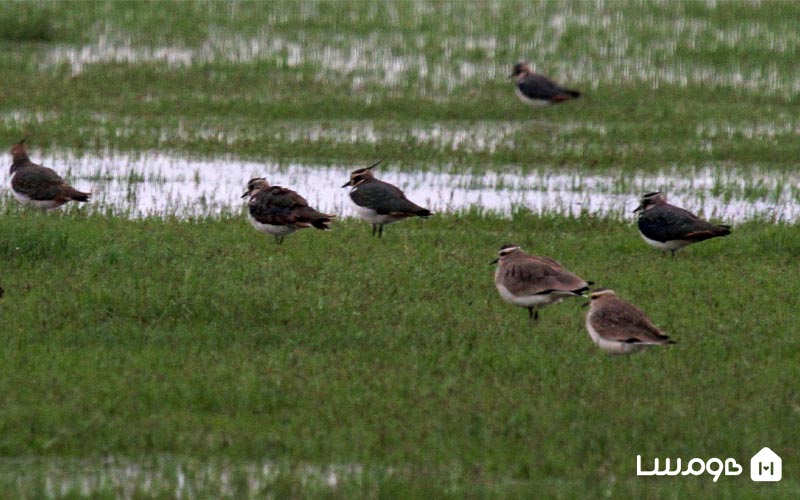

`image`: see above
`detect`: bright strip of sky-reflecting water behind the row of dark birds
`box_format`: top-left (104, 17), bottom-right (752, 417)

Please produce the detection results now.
top-left (3, 152), bottom-right (800, 222)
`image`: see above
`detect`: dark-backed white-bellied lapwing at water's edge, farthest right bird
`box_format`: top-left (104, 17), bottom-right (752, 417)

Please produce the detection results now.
top-left (634, 192), bottom-right (731, 257)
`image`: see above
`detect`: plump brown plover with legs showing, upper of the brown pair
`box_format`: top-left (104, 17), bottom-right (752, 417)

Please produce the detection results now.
top-left (492, 245), bottom-right (592, 320)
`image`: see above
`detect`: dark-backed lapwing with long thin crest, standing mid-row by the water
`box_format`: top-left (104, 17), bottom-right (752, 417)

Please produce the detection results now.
top-left (342, 161), bottom-right (432, 238)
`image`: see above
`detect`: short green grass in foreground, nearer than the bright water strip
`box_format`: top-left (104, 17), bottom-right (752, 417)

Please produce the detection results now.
top-left (0, 211), bottom-right (800, 498)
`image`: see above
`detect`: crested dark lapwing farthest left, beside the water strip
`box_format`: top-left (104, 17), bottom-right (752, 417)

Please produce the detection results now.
top-left (10, 139), bottom-right (91, 210)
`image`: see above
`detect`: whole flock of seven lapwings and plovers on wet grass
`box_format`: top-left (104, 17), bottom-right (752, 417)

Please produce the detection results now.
top-left (4, 63), bottom-right (730, 354)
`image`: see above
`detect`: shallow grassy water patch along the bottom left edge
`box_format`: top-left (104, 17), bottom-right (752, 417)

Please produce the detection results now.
top-left (0, 455), bottom-right (376, 498)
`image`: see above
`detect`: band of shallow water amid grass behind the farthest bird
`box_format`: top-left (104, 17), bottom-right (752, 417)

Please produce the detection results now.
top-left (39, 12), bottom-right (800, 98)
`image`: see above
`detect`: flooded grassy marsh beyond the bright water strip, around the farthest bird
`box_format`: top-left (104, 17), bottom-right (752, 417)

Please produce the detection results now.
top-left (0, 1), bottom-right (800, 170)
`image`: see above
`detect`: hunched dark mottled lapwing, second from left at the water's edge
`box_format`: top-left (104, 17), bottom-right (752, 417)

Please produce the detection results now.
top-left (242, 177), bottom-right (336, 244)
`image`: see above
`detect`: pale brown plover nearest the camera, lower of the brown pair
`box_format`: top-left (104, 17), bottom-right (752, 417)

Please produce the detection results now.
top-left (586, 289), bottom-right (675, 354)
